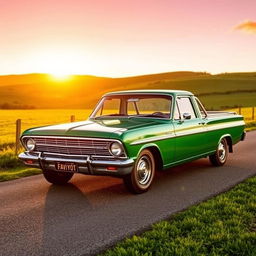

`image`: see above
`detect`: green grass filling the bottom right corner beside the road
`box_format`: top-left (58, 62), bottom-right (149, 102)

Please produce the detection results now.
top-left (102, 177), bottom-right (256, 256)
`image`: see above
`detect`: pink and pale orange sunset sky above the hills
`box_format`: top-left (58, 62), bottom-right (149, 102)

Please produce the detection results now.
top-left (0, 0), bottom-right (256, 77)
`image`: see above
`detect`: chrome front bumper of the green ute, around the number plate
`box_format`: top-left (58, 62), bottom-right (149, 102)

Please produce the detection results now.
top-left (19, 151), bottom-right (134, 176)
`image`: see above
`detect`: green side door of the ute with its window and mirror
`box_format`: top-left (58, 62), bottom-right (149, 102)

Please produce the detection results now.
top-left (173, 96), bottom-right (206, 162)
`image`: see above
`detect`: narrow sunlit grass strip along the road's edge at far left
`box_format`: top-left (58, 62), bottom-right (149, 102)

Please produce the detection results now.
top-left (0, 167), bottom-right (42, 182)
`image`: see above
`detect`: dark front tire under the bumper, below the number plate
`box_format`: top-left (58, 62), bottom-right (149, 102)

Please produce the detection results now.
top-left (43, 169), bottom-right (74, 185)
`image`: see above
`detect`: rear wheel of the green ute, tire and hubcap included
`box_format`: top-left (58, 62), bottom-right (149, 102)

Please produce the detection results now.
top-left (209, 138), bottom-right (228, 166)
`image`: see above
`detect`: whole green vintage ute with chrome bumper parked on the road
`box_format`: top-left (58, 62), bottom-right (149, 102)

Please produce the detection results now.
top-left (19, 90), bottom-right (245, 193)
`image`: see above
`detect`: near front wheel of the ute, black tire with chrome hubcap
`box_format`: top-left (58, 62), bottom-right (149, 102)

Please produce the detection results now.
top-left (123, 149), bottom-right (155, 194)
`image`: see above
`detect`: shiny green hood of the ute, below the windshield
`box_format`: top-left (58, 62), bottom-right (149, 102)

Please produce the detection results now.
top-left (23, 118), bottom-right (161, 139)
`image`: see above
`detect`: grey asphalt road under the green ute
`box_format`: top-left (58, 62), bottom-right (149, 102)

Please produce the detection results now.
top-left (0, 132), bottom-right (256, 256)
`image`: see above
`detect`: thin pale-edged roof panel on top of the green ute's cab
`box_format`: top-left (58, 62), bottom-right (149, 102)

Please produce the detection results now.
top-left (104, 90), bottom-right (193, 96)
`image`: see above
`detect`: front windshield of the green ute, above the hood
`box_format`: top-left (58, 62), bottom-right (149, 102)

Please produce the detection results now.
top-left (91, 94), bottom-right (172, 118)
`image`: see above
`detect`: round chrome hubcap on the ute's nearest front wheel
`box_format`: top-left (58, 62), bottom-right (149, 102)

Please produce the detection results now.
top-left (137, 156), bottom-right (152, 185)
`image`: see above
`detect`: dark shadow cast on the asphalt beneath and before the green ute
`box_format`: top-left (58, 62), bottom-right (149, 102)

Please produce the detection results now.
top-left (41, 159), bottom-right (213, 255)
